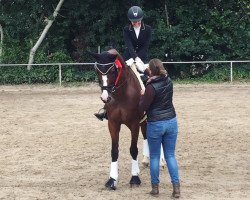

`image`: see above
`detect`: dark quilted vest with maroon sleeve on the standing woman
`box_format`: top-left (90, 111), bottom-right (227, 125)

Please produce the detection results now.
top-left (139, 76), bottom-right (176, 122)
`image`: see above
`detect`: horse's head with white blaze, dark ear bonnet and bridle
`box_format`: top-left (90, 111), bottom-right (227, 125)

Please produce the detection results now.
top-left (92, 50), bottom-right (121, 103)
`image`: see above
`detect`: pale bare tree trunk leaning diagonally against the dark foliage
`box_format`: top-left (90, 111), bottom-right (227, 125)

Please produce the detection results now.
top-left (27, 0), bottom-right (64, 70)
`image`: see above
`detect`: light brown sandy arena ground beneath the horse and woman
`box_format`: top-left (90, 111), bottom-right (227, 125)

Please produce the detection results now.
top-left (0, 84), bottom-right (250, 200)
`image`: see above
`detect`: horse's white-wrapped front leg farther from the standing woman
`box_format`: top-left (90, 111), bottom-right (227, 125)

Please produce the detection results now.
top-left (105, 122), bottom-right (121, 190)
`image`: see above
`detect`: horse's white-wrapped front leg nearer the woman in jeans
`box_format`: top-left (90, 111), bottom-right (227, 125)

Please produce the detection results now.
top-left (129, 125), bottom-right (141, 187)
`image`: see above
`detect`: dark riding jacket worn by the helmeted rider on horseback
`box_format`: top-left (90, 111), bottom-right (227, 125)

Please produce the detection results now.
top-left (123, 23), bottom-right (152, 63)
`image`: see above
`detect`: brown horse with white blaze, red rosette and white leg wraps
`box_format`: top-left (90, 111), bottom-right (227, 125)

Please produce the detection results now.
top-left (92, 49), bottom-right (146, 190)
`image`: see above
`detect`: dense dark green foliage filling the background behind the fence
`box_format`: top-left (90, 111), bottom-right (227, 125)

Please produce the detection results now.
top-left (0, 0), bottom-right (250, 83)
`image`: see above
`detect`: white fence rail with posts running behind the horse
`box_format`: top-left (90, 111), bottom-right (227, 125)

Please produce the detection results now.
top-left (0, 60), bottom-right (250, 86)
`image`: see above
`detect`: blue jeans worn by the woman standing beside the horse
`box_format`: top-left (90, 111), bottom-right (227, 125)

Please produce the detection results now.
top-left (147, 118), bottom-right (179, 184)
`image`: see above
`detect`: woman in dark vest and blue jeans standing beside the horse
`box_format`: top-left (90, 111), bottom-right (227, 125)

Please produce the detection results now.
top-left (139, 59), bottom-right (180, 198)
